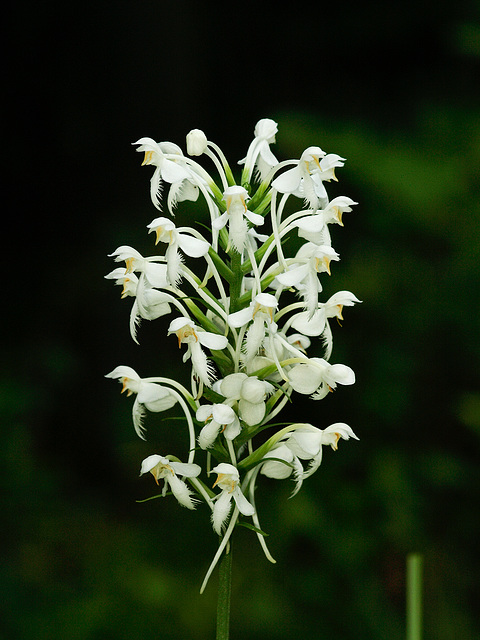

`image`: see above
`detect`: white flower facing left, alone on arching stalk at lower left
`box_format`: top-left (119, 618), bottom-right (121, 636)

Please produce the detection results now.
top-left (105, 365), bottom-right (177, 440)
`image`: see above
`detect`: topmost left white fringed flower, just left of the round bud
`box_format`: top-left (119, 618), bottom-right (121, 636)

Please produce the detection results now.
top-left (133, 138), bottom-right (192, 209)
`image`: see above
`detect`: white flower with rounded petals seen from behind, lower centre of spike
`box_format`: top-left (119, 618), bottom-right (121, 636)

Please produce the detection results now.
top-left (213, 373), bottom-right (273, 426)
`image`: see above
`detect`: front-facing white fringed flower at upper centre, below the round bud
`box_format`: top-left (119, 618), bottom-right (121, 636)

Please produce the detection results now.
top-left (212, 186), bottom-right (264, 253)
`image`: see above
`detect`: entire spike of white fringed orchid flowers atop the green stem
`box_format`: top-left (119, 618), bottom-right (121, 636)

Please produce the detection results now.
top-left (106, 119), bottom-right (359, 584)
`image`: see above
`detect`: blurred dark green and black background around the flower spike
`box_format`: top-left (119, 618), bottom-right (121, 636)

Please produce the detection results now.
top-left (4, 0), bottom-right (480, 640)
